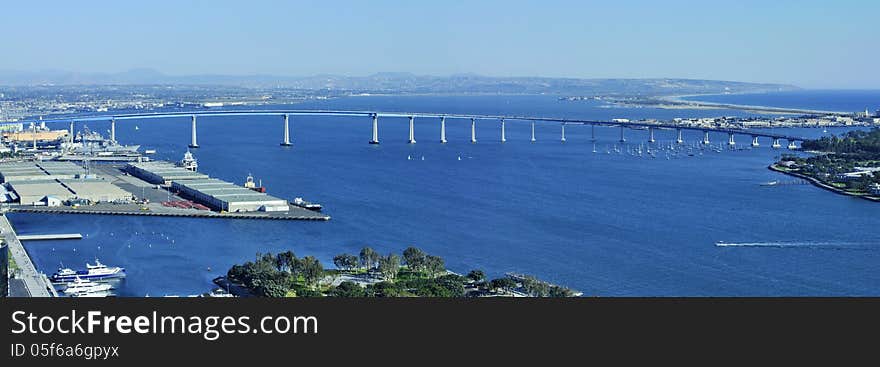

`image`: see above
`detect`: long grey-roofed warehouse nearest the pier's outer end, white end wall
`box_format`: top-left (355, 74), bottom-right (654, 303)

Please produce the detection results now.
top-left (171, 178), bottom-right (290, 212)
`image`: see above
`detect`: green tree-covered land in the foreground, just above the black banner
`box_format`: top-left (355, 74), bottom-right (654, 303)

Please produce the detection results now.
top-left (214, 247), bottom-right (581, 298)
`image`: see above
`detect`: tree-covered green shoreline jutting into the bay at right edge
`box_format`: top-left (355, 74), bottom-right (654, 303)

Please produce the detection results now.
top-left (770, 128), bottom-right (880, 201)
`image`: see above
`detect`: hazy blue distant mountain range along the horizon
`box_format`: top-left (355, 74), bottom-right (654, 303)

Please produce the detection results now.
top-left (0, 69), bottom-right (799, 95)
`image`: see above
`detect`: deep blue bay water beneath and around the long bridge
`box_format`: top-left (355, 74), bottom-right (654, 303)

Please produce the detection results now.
top-left (10, 96), bottom-right (880, 296)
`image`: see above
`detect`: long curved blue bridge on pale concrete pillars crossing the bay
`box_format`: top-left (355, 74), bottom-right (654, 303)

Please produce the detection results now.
top-left (34, 109), bottom-right (808, 149)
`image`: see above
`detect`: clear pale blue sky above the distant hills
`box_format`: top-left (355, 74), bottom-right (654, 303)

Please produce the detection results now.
top-left (0, 0), bottom-right (880, 89)
